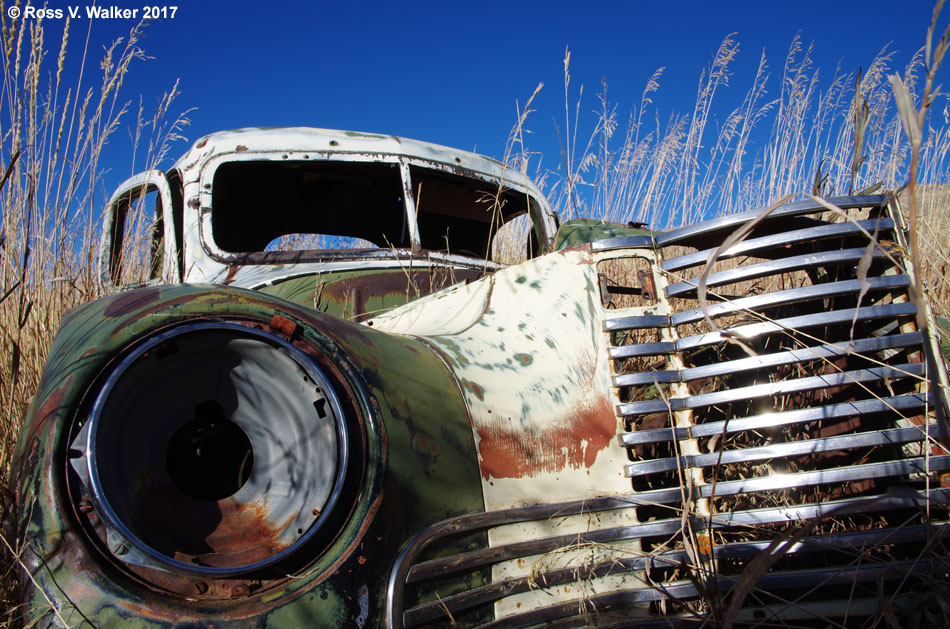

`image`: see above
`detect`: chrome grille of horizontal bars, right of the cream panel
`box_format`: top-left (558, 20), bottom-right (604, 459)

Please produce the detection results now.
top-left (608, 197), bottom-right (950, 624)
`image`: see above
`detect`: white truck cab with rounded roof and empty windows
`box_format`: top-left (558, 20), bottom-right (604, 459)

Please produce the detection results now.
top-left (99, 129), bottom-right (558, 320)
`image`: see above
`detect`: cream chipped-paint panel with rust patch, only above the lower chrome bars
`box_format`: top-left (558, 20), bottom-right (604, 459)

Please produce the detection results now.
top-left (370, 251), bottom-right (629, 509)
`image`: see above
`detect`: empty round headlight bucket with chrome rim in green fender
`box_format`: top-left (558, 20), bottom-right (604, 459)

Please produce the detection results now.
top-left (71, 322), bottom-right (349, 577)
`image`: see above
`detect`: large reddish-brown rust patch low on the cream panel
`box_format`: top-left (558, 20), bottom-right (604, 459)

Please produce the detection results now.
top-left (477, 397), bottom-right (617, 480)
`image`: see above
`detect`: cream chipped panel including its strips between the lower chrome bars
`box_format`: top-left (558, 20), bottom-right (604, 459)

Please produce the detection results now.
top-left (372, 244), bottom-right (660, 618)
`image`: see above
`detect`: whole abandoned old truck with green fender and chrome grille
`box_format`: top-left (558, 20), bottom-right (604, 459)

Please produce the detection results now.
top-left (17, 129), bottom-right (950, 628)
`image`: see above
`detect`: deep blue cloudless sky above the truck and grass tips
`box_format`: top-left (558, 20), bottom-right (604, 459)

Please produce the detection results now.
top-left (20, 0), bottom-right (950, 200)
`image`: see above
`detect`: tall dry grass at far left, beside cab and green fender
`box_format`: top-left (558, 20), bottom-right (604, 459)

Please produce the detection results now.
top-left (0, 6), bottom-right (186, 621)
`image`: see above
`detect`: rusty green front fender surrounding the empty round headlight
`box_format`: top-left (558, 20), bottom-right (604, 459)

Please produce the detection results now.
top-left (17, 286), bottom-right (482, 626)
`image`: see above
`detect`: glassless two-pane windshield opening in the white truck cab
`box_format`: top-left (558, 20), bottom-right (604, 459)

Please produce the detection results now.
top-left (211, 160), bottom-right (535, 264)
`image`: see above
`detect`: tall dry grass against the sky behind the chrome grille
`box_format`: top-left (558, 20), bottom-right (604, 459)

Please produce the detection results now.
top-left (543, 18), bottom-right (950, 240)
